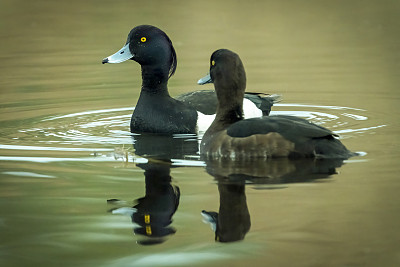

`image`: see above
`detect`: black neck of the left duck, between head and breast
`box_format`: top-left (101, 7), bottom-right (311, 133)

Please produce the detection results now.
top-left (142, 65), bottom-right (169, 96)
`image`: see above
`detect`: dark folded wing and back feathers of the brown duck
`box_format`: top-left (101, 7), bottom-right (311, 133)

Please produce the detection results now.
top-left (220, 116), bottom-right (355, 158)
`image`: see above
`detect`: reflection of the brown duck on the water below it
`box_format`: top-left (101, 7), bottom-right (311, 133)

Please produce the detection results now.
top-left (201, 158), bottom-right (343, 242)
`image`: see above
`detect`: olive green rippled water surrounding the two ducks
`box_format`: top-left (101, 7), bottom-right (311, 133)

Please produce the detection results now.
top-left (0, 0), bottom-right (400, 266)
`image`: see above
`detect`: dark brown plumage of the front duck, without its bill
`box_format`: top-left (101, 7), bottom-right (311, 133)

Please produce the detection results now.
top-left (200, 49), bottom-right (355, 159)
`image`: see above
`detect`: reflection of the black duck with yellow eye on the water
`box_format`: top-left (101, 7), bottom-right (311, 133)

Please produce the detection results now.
top-left (108, 135), bottom-right (198, 245)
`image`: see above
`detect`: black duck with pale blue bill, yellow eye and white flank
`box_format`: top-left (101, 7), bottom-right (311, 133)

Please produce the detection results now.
top-left (102, 25), bottom-right (276, 134)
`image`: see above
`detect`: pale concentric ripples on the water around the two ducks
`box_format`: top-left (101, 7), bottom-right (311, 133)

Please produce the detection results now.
top-left (0, 104), bottom-right (386, 166)
